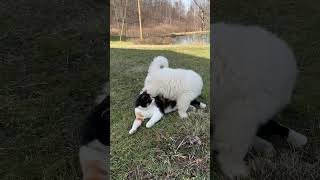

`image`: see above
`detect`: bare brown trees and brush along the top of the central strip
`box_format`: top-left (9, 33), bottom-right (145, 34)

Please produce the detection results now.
top-left (110, 0), bottom-right (210, 37)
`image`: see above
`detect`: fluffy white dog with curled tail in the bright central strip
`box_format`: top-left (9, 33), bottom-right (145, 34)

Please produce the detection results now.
top-left (143, 56), bottom-right (203, 118)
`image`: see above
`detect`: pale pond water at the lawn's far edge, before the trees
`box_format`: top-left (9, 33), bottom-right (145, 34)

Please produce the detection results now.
top-left (174, 33), bottom-right (210, 44)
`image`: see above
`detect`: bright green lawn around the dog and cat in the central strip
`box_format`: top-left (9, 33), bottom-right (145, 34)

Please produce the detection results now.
top-left (110, 41), bottom-right (210, 179)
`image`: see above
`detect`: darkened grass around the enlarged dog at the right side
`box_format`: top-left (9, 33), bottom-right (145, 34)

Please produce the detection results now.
top-left (212, 0), bottom-right (320, 180)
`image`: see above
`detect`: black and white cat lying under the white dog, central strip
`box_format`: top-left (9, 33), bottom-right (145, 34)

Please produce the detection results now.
top-left (129, 91), bottom-right (206, 134)
